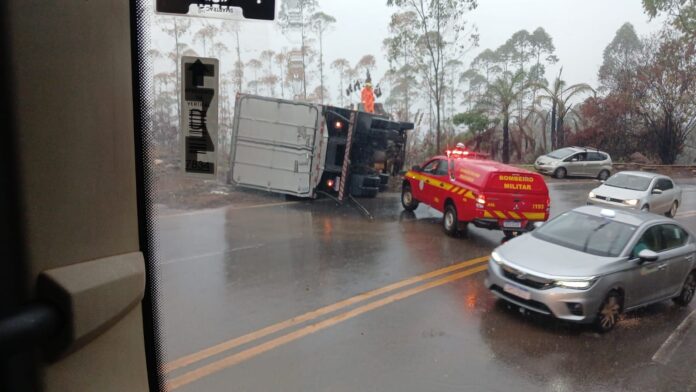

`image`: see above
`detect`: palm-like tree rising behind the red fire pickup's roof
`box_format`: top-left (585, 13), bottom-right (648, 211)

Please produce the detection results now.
top-left (483, 70), bottom-right (531, 163)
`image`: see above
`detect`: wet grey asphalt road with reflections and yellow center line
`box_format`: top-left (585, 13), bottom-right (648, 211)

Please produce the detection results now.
top-left (158, 179), bottom-right (696, 391)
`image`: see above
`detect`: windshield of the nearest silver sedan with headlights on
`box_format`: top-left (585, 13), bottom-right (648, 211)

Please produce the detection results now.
top-left (534, 212), bottom-right (636, 257)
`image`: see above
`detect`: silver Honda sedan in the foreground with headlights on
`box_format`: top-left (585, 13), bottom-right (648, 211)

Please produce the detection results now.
top-left (486, 206), bottom-right (696, 332)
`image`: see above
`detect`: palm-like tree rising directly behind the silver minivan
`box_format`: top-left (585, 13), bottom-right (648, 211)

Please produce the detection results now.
top-left (536, 68), bottom-right (594, 149)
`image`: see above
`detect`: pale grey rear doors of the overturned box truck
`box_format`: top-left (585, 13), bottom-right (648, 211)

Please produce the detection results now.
top-left (228, 94), bottom-right (328, 197)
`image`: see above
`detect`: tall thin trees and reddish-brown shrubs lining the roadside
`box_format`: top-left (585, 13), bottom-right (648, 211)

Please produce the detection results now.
top-left (150, 0), bottom-right (696, 172)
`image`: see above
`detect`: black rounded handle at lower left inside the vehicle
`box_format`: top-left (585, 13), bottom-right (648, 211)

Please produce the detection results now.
top-left (0, 303), bottom-right (60, 358)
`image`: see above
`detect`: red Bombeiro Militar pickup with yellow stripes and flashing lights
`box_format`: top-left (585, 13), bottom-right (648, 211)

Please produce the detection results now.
top-left (401, 151), bottom-right (551, 237)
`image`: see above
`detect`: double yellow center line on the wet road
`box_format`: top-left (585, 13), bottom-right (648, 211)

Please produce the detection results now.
top-left (163, 256), bottom-right (488, 391)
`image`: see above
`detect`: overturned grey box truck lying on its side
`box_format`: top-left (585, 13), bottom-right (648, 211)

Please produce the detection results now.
top-left (228, 94), bottom-right (413, 200)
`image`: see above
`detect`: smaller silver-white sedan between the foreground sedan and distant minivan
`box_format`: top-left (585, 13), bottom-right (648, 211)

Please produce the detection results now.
top-left (587, 171), bottom-right (682, 217)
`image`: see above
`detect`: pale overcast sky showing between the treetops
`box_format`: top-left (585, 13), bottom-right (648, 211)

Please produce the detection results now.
top-left (153, 0), bottom-right (662, 103)
